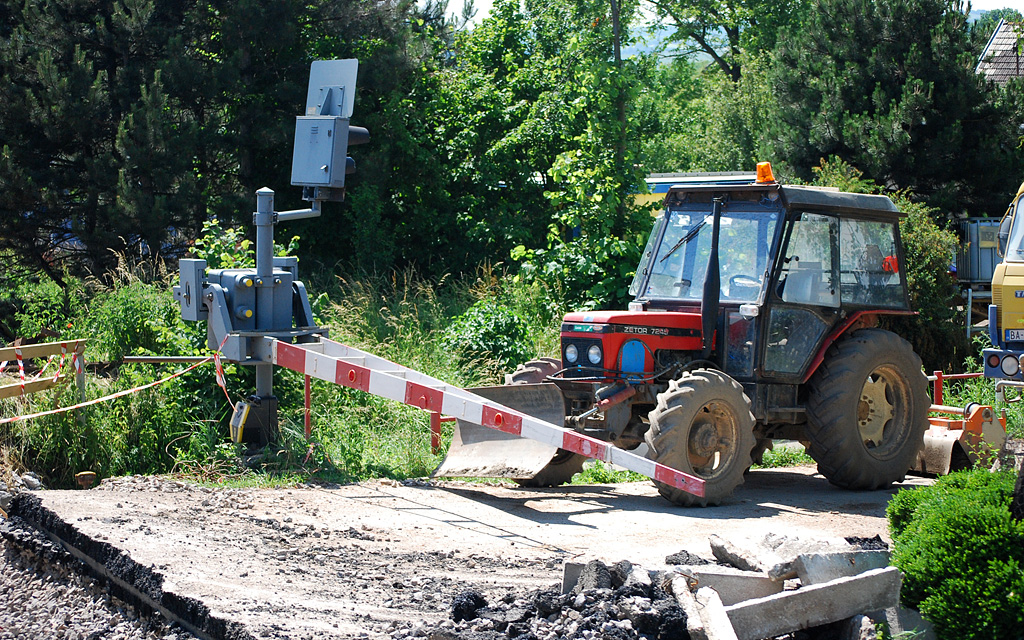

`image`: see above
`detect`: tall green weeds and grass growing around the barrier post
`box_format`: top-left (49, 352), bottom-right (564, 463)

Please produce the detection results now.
top-left (0, 254), bottom-right (561, 486)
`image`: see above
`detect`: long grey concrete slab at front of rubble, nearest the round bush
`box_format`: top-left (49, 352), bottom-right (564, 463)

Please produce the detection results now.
top-left (726, 566), bottom-right (902, 640)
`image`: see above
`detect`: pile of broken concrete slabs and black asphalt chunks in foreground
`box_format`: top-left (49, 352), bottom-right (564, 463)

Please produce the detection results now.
top-left (417, 535), bottom-right (929, 640)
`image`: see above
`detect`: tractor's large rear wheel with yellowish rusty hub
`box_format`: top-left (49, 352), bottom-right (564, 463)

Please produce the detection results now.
top-left (806, 329), bottom-right (930, 490)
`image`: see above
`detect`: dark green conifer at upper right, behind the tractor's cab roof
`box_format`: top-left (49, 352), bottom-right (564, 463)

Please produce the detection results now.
top-left (772, 0), bottom-right (1024, 215)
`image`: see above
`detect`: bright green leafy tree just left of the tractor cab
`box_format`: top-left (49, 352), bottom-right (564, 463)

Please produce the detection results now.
top-left (513, 2), bottom-right (654, 304)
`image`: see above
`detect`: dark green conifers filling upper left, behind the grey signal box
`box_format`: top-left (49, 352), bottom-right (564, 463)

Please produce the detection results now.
top-left (0, 0), bottom-right (432, 282)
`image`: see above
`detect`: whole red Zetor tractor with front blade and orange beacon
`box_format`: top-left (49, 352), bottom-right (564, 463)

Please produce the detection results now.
top-left (437, 163), bottom-right (930, 505)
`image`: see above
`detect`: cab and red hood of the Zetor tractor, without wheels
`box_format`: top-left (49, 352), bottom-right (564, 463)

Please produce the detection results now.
top-left (562, 169), bottom-right (909, 383)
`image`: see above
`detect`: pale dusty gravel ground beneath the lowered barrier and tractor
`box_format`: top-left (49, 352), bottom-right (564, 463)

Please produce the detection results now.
top-left (0, 454), bottom-right (958, 640)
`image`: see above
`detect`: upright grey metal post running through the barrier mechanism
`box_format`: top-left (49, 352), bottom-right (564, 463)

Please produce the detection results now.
top-left (244, 186), bottom-right (278, 447)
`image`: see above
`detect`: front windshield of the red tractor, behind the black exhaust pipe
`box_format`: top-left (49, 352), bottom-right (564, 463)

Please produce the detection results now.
top-left (631, 203), bottom-right (781, 302)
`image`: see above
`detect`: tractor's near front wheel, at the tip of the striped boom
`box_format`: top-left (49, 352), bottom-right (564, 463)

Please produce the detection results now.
top-left (644, 369), bottom-right (756, 507)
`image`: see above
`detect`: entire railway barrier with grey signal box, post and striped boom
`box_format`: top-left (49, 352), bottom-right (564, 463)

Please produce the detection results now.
top-left (174, 60), bottom-right (705, 496)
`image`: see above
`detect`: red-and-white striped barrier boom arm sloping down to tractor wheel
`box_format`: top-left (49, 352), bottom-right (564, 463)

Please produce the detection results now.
top-left (271, 338), bottom-right (705, 497)
